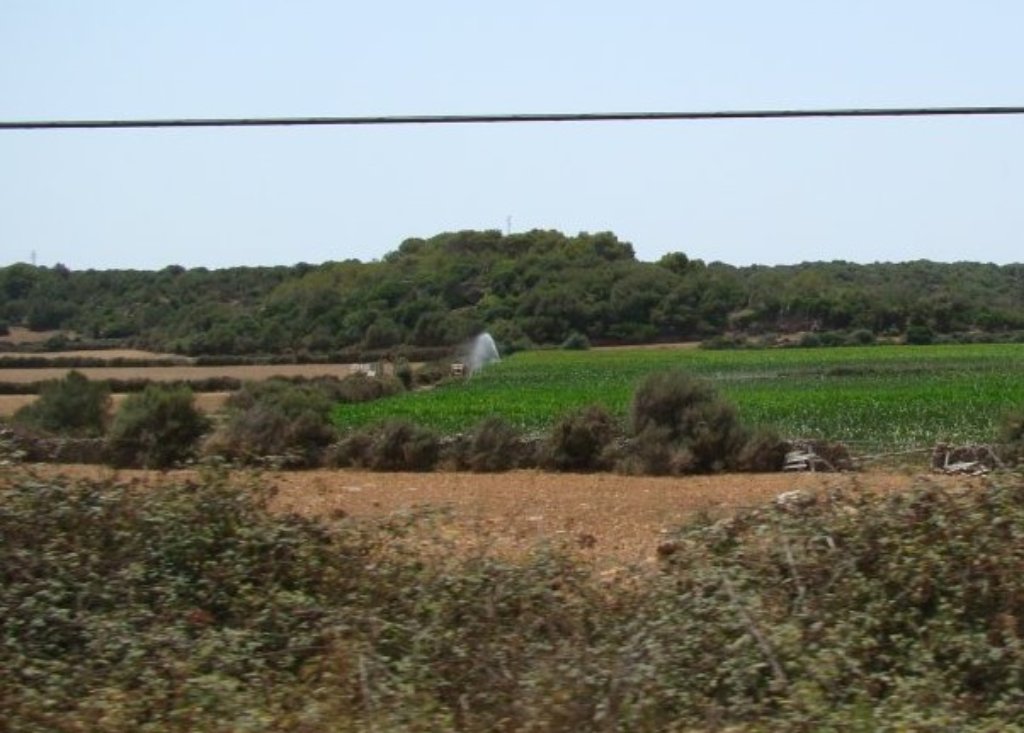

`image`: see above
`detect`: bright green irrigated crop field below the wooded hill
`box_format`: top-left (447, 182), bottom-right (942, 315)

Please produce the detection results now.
top-left (335, 344), bottom-right (1024, 449)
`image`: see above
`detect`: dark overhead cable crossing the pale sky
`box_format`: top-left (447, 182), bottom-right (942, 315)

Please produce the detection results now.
top-left (6, 106), bottom-right (1024, 130)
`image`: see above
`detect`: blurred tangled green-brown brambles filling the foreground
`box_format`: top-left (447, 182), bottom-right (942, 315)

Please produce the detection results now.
top-left (0, 472), bottom-right (1024, 733)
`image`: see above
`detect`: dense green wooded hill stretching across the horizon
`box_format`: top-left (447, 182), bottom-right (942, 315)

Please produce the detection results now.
top-left (0, 230), bottom-right (1024, 355)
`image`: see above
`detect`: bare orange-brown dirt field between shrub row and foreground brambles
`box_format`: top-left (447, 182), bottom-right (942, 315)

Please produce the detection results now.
top-left (24, 466), bottom-right (969, 572)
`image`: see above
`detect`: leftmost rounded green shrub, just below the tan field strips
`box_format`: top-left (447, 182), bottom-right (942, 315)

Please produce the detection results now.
top-left (14, 371), bottom-right (111, 436)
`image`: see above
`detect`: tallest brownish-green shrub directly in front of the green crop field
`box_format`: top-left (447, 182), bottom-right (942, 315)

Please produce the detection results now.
top-left (623, 372), bottom-right (748, 475)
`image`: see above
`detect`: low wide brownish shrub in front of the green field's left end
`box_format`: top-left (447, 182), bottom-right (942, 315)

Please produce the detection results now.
top-left (330, 420), bottom-right (440, 471)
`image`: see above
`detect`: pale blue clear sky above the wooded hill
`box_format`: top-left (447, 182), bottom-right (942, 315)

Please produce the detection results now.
top-left (0, 0), bottom-right (1024, 269)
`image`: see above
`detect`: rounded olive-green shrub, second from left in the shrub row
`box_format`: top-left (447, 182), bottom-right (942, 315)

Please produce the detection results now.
top-left (106, 384), bottom-right (209, 468)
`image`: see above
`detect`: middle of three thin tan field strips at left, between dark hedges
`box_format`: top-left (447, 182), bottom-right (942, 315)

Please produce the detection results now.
top-left (0, 364), bottom-right (366, 384)
